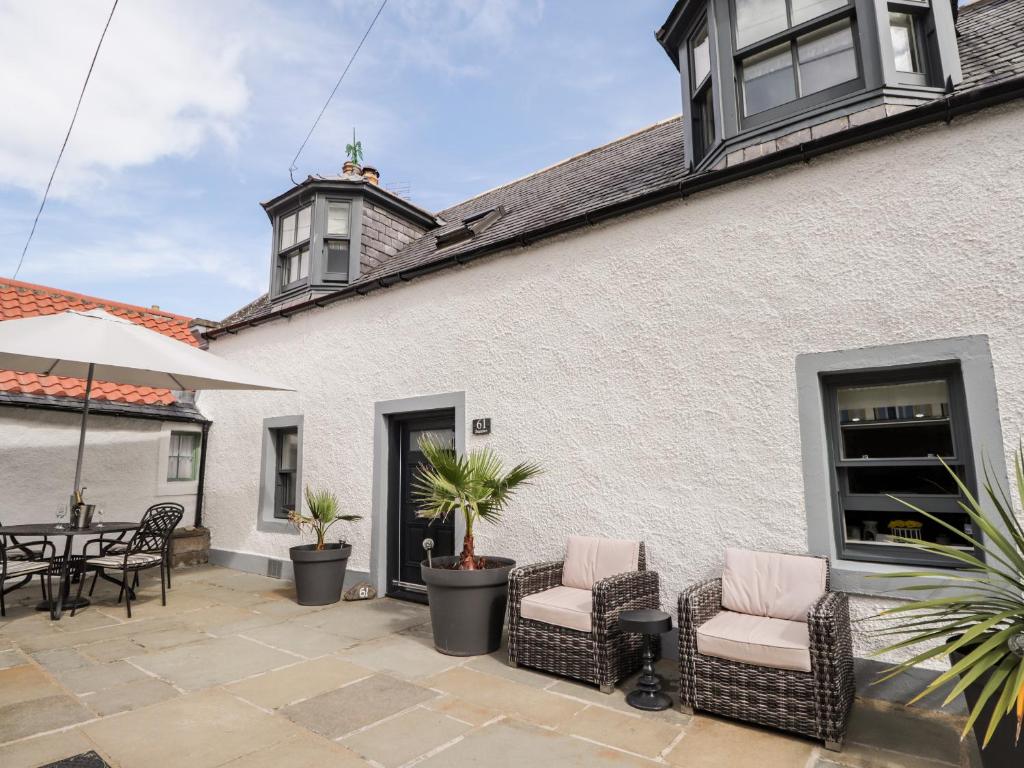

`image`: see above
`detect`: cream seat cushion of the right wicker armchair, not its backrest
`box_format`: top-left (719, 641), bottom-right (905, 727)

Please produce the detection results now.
top-left (697, 610), bottom-right (811, 672)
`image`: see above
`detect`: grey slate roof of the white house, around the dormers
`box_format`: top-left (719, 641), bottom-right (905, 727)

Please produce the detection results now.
top-left (221, 0), bottom-right (1024, 327)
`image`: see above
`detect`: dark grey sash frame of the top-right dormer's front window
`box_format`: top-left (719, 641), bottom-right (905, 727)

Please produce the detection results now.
top-left (728, 0), bottom-right (864, 130)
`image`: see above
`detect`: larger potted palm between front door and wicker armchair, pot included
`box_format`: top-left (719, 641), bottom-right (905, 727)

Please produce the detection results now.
top-left (415, 435), bottom-right (541, 656)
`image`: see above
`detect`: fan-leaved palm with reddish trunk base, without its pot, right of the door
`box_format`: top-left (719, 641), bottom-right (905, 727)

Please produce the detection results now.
top-left (414, 434), bottom-right (542, 570)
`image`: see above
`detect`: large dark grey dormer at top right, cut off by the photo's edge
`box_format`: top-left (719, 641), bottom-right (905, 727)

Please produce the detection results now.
top-left (657, 0), bottom-right (963, 173)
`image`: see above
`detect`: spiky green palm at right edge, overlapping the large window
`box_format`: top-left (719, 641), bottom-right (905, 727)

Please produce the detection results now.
top-left (879, 446), bottom-right (1024, 768)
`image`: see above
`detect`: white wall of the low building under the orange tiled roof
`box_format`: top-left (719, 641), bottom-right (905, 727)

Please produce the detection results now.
top-left (0, 407), bottom-right (201, 525)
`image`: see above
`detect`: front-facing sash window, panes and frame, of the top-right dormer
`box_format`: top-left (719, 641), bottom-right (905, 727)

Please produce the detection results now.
top-left (733, 0), bottom-right (861, 119)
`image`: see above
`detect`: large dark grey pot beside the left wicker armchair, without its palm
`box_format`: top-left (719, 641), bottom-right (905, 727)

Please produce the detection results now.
top-left (420, 557), bottom-right (515, 656)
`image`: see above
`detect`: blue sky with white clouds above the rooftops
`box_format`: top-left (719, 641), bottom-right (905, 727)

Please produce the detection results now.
top-left (0, 0), bottom-right (680, 319)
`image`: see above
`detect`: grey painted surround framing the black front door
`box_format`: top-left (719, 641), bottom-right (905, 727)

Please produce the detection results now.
top-left (370, 392), bottom-right (466, 595)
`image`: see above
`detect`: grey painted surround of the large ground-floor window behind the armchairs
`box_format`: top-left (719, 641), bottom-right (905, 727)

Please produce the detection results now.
top-left (796, 335), bottom-right (1007, 598)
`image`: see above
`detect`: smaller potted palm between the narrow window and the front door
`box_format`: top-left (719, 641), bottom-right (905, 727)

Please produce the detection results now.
top-left (288, 485), bottom-right (362, 605)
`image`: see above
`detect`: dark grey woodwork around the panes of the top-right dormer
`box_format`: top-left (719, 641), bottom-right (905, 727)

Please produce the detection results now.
top-left (659, 0), bottom-right (963, 172)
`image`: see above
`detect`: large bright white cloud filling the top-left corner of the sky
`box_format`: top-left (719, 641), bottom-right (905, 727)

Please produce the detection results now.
top-left (0, 0), bottom-right (296, 198)
